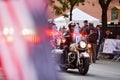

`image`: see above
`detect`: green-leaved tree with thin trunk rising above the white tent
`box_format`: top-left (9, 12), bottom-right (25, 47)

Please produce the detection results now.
top-left (50, 0), bottom-right (85, 21)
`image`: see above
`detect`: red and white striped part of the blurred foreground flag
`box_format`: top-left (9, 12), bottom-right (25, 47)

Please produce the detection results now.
top-left (0, 0), bottom-right (42, 80)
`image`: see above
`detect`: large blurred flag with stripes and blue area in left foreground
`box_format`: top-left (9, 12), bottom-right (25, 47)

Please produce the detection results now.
top-left (0, 0), bottom-right (58, 80)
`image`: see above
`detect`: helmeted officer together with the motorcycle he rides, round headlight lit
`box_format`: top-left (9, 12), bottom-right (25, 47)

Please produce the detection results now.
top-left (59, 22), bottom-right (90, 75)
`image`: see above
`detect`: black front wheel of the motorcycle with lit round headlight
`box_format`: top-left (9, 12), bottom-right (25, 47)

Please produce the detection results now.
top-left (78, 58), bottom-right (89, 75)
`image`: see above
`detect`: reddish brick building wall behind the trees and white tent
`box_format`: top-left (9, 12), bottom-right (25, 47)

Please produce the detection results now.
top-left (48, 0), bottom-right (120, 21)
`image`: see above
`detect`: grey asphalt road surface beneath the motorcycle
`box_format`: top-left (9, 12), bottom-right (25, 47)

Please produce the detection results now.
top-left (58, 60), bottom-right (120, 80)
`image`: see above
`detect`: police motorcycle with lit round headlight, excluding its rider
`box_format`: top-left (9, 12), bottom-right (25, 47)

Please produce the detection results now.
top-left (54, 22), bottom-right (90, 75)
